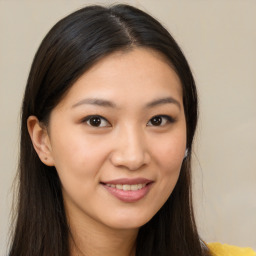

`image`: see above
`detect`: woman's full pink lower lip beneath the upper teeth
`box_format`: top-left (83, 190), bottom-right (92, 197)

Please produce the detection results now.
top-left (102, 183), bottom-right (152, 203)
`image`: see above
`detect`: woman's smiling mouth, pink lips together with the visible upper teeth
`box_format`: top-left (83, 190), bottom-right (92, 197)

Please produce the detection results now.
top-left (101, 178), bottom-right (153, 203)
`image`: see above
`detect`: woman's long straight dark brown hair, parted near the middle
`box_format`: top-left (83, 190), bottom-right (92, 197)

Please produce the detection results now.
top-left (9, 5), bottom-right (208, 256)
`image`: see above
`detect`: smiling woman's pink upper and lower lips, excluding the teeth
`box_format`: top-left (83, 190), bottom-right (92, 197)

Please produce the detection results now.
top-left (101, 178), bottom-right (153, 203)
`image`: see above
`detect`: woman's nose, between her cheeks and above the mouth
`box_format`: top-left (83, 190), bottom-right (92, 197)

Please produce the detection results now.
top-left (111, 129), bottom-right (151, 171)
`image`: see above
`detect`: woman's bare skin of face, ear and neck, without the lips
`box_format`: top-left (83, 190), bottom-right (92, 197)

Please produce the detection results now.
top-left (28, 48), bottom-right (186, 256)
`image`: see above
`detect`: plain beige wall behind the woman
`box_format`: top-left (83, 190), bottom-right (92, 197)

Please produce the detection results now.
top-left (0, 0), bottom-right (256, 255)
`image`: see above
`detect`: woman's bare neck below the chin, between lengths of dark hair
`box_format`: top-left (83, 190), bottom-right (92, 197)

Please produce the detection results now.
top-left (69, 210), bottom-right (138, 256)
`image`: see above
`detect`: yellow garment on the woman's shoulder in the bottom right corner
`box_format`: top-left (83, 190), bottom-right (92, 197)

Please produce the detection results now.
top-left (207, 243), bottom-right (256, 256)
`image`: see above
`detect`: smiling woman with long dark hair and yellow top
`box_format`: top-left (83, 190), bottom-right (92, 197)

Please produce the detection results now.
top-left (10, 5), bottom-right (253, 256)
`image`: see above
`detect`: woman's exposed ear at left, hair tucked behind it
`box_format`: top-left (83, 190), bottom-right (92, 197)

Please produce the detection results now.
top-left (27, 116), bottom-right (54, 166)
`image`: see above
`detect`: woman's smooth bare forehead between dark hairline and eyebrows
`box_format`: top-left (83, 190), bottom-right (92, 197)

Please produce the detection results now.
top-left (57, 47), bottom-right (182, 108)
